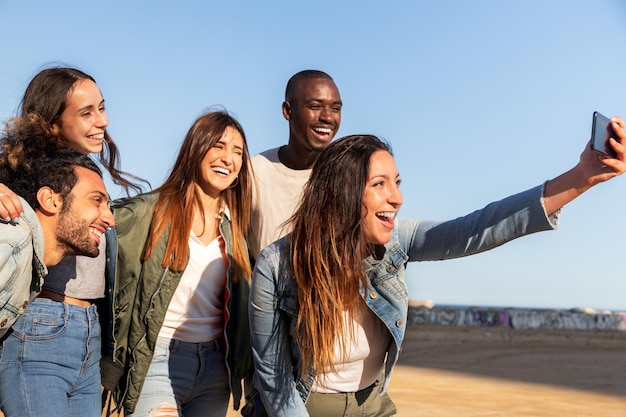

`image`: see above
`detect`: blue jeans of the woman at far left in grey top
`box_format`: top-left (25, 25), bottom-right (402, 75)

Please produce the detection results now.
top-left (0, 298), bottom-right (102, 417)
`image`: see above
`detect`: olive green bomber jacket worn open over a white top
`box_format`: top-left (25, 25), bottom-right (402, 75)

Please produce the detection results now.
top-left (101, 192), bottom-right (254, 412)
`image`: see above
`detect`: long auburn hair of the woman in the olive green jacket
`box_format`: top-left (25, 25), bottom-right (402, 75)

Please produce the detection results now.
top-left (142, 111), bottom-right (252, 279)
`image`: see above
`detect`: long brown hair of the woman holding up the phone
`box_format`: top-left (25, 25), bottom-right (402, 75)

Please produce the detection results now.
top-left (287, 135), bottom-right (391, 375)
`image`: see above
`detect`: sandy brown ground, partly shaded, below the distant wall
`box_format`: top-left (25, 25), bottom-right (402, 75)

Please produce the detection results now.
top-left (0, 326), bottom-right (626, 417)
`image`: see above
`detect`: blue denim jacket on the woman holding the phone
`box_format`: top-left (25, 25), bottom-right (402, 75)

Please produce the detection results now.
top-left (249, 186), bottom-right (558, 417)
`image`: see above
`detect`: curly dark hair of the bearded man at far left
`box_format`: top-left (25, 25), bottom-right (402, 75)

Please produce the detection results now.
top-left (0, 114), bottom-right (102, 209)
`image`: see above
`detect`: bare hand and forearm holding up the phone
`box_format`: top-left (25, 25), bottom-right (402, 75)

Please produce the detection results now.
top-left (543, 117), bottom-right (626, 215)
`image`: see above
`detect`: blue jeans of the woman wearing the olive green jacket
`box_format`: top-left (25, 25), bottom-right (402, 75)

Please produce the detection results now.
top-left (126, 337), bottom-right (230, 417)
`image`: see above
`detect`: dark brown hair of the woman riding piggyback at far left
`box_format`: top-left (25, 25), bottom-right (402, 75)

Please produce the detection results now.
top-left (20, 67), bottom-right (149, 195)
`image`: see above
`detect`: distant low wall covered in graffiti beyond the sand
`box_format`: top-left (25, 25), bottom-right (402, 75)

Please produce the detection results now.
top-left (408, 305), bottom-right (626, 330)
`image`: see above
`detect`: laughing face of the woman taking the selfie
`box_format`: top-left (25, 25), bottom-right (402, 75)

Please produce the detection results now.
top-left (363, 151), bottom-right (402, 245)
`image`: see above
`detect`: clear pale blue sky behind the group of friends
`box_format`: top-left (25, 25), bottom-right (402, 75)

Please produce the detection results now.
top-left (0, 0), bottom-right (626, 310)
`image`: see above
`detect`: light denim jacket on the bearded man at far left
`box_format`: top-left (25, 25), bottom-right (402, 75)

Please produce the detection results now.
top-left (0, 198), bottom-right (48, 338)
